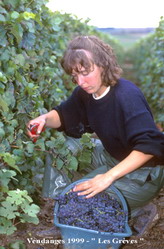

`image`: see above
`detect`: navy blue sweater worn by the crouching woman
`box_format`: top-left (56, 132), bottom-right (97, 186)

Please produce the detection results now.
top-left (54, 79), bottom-right (164, 160)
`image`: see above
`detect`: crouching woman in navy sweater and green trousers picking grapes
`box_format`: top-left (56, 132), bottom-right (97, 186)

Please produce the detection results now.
top-left (27, 36), bottom-right (164, 235)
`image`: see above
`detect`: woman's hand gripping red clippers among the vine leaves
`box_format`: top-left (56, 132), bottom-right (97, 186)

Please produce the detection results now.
top-left (27, 115), bottom-right (46, 141)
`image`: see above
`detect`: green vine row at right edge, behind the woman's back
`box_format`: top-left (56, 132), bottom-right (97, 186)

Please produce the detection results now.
top-left (128, 17), bottom-right (164, 128)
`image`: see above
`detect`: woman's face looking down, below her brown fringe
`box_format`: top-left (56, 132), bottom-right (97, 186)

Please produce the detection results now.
top-left (72, 64), bottom-right (107, 97)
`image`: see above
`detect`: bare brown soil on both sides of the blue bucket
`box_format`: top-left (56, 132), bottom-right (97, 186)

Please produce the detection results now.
top-left (0, 190), bottom-right (164, 249)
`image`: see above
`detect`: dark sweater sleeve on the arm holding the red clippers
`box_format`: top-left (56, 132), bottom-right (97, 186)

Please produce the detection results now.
top-left (53, 87), bottom-right (92, 138)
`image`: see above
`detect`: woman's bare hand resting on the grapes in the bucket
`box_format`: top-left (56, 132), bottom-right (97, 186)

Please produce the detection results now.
top-left (73, 173), bottom-right (113, 198)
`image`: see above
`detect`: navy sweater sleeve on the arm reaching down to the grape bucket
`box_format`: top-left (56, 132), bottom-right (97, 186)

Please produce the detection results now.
top-left (119, 80), bottom-right (164, 160)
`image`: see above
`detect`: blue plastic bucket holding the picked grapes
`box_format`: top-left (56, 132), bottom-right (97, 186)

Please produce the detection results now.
top-left (54, 179), bottom-right (132, 249)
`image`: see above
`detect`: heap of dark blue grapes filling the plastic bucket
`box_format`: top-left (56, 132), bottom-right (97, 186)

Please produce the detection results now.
top-left (56, 191), bottom-right (126, 233)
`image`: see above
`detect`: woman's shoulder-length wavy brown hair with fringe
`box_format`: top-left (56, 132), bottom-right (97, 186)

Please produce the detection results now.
top-left (61, 36), bottom-right (122, 86)
